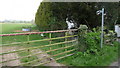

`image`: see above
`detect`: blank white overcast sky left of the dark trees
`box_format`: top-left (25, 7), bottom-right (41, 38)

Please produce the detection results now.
top-left (0, 0), bottom-right (42, 21)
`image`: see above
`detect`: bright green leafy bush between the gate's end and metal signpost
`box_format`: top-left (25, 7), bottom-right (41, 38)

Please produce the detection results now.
top-left (78, 32), bottom-right (100, 53)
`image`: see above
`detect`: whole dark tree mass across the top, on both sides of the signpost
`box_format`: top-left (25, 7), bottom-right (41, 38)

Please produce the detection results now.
top-left (35, 2), bottom-right (118, 30)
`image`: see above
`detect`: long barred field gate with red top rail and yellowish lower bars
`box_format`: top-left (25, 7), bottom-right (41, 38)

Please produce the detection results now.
top-left (0, 29), bottom-right (78, 66)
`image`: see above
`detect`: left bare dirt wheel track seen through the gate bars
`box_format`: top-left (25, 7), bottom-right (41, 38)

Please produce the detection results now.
top-left (0, 46), bottom-right (20, 67)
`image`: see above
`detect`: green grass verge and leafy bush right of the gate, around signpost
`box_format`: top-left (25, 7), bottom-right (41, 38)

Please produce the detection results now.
top-left (58, 29), bottom-right (120, 66)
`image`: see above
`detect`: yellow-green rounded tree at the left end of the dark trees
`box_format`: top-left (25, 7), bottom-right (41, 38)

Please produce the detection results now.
top-left (35, 2), bottom-right (66, 31)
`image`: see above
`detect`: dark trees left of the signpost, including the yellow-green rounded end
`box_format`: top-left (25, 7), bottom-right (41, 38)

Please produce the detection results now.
top-left (35, 2), bottom-right (98, 30)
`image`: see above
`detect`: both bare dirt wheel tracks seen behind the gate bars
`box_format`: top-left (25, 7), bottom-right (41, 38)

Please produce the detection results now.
top-left (0, 46), bottom-right (65, 68)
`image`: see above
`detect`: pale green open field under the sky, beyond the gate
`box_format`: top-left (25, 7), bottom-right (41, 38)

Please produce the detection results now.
top-left (0, 23), bottom-right (32, 34)
